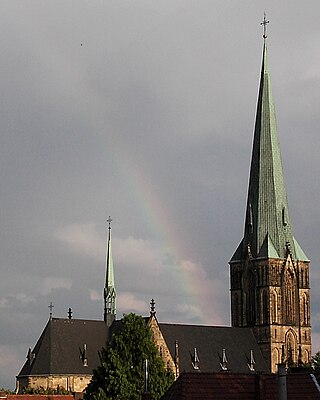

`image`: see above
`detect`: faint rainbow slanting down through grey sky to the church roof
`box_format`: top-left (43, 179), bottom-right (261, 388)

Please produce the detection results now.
top-left (77, 78), bottom-right (224, 324)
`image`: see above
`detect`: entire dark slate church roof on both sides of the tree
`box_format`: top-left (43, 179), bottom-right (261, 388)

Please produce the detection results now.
top-left (18, 318), bottom-right (268, 377)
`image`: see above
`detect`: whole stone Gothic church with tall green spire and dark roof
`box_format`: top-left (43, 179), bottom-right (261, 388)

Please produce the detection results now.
top-left (17, 23), bottom-right (311, 393)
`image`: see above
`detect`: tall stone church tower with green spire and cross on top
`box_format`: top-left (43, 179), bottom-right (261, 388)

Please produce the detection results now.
top-left (229, 18), bottom-right (311, 372)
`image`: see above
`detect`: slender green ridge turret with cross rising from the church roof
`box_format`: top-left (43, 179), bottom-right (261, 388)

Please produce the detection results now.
top-left (103, 217), bottom-right (116, 326)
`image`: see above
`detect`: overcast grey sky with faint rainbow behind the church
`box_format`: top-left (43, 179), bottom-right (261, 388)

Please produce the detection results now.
top-left (0, 0), bottom-right (320, 388)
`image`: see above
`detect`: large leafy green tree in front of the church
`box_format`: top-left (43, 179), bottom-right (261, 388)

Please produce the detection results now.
top-left (85, 314), bottom-right (174, 400)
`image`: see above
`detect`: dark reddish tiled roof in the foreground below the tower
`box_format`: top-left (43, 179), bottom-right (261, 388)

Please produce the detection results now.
top-left (161, 372), bottom-right (320, 400)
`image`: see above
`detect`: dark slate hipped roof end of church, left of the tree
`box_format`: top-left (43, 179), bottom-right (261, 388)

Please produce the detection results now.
top-left (18, 318), bottom-right (108, 377)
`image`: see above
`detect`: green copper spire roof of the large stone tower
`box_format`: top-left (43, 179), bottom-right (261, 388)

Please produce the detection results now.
top-left (231, 39), bottom-right (307, 262)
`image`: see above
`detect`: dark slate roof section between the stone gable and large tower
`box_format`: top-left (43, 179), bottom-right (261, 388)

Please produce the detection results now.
top-left (159, 323), bottom-right (268, 373)
